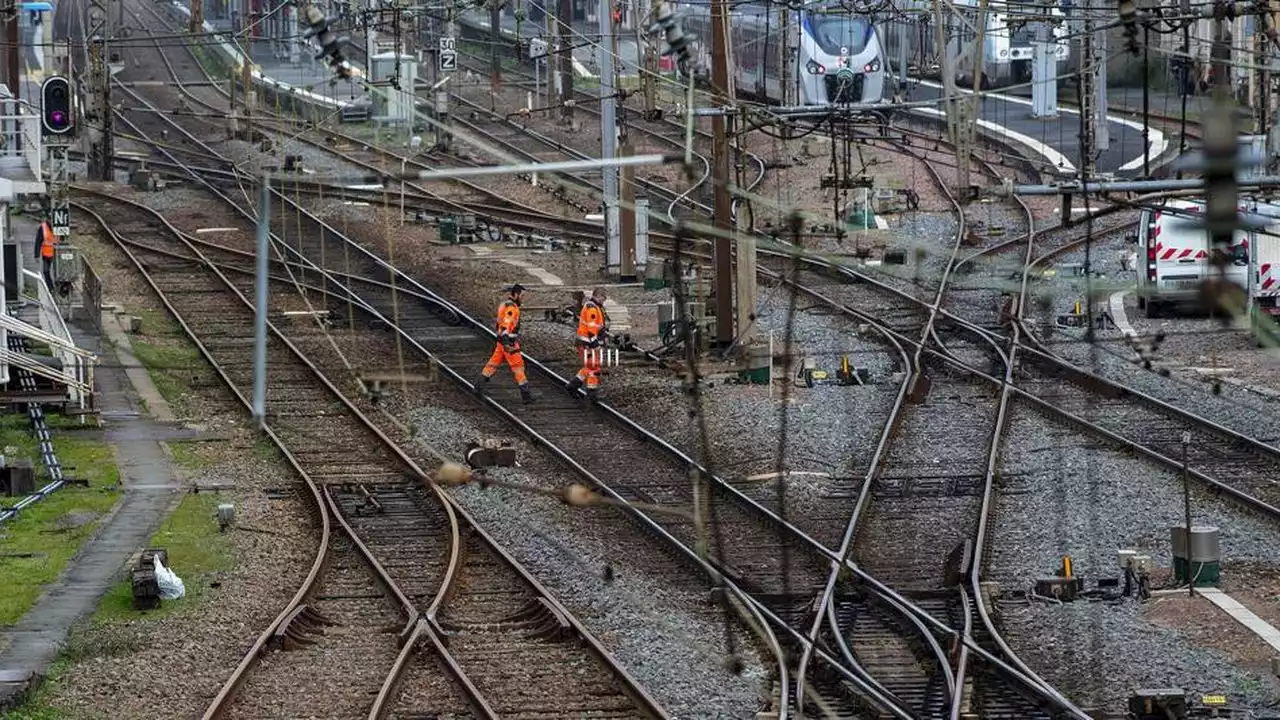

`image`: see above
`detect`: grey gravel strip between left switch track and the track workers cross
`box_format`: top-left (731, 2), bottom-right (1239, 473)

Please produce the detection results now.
top-left (410, 406), bottom-right (769, 717)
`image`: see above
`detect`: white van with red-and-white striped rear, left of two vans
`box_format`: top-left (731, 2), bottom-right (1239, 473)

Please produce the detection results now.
top-left (1137, 200), bottom-right (1249, 318)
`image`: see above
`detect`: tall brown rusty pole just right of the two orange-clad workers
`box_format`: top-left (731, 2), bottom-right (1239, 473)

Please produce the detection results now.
top-left (712, 0), bottom-right (735, 347)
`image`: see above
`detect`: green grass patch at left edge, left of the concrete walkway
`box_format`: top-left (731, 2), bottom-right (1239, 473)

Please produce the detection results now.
top-left (0, 415), bottom-right (120, 625)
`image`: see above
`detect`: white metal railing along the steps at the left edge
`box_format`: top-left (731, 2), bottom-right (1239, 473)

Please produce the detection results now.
top-left (0, 269), bottom-right (97, 410)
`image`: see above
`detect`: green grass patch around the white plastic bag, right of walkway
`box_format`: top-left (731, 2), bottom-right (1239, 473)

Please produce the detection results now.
top-left (95, 492), bottom-right (232, 623)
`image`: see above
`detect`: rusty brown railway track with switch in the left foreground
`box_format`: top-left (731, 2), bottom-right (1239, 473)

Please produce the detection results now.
top-left (73, 183), bottom-right (664, 717)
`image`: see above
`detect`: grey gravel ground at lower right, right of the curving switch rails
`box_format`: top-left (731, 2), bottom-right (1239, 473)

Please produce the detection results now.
top-left (986, 404), bottom-right (1280, 706)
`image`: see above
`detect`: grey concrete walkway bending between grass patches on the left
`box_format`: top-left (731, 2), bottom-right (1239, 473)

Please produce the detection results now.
top-left (0, 313), bottom-right (180, 711)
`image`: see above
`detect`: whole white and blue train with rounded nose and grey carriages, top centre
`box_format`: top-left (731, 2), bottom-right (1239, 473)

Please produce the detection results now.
top-left (678, 1), bottom-right (892, 105)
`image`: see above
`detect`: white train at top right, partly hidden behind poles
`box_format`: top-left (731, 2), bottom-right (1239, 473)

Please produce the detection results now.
top-left (877, 0), bottom-right (1071, 88)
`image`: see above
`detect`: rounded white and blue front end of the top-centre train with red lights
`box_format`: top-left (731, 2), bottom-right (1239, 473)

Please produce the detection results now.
top-left (800, 6), bottom-right (886, 105)
